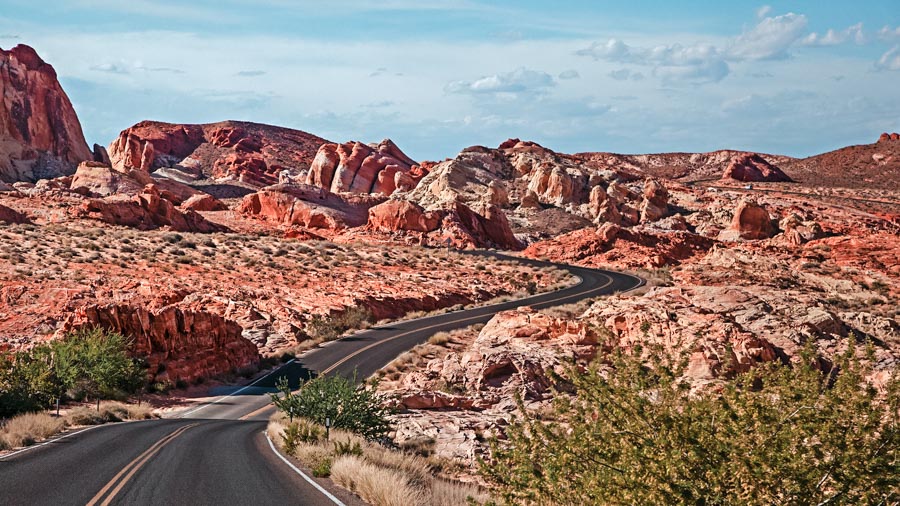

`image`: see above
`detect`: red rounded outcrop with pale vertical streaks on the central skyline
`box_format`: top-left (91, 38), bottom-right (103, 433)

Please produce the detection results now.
top-left (306, 139), bottom-right (425, 195)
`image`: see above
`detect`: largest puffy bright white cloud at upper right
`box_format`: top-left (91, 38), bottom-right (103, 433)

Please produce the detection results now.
top-left (726, 12), bottom-right (807, 60)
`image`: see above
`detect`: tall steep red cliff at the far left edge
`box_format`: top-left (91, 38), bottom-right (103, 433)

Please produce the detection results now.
top-left (0, 44), bottom-right (93, 183)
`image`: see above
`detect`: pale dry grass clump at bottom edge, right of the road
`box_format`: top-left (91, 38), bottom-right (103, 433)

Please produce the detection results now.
top-left (331, 456), bottom-right (427, 506)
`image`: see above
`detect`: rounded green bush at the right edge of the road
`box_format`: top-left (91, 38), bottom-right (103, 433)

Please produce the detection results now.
top-left (271, 373), bottom-right (391, 440)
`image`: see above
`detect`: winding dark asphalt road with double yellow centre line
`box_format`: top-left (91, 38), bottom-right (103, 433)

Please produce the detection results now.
top-left (0, 252), bottom-right (643, 506)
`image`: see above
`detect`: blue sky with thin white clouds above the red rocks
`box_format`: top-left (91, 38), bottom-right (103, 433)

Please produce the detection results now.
top-left (0, 0), bottom-right (900, 160)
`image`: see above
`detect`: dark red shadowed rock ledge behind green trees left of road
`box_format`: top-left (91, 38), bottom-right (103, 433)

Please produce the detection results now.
top-left (64, 304), bottom-right (259, 383)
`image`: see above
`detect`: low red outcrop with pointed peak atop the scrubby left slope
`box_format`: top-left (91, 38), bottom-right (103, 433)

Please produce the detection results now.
top-left (73, 184), bottom-right (225, 233)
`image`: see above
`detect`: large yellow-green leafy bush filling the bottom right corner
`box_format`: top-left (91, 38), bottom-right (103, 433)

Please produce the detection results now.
top-left (482, 337), bottom-right (900, 505)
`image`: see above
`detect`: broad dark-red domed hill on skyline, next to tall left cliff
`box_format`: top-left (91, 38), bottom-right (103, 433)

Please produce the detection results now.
top-left (108, 121), bottom-right (327, 187)
